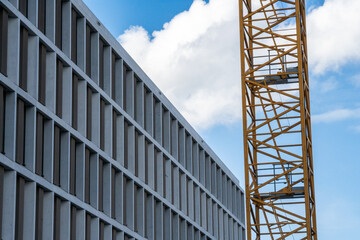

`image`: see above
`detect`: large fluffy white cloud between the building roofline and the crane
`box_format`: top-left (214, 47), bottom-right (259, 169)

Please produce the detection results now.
top-left (118, 0), bottom-right (241, 128)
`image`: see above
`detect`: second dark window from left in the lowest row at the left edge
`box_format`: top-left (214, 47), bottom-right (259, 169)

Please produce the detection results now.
top-left (15, 176), bottom-right (25, 240)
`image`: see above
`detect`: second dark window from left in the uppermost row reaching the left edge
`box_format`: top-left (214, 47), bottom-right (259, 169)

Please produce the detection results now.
top-left (19, 26), bottom-right (29, 91)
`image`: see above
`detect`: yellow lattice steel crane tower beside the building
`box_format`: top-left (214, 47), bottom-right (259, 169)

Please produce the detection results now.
top-left (239, 0), bottom-right (317, 240)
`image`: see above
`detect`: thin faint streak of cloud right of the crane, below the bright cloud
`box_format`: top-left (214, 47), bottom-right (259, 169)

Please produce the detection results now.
top-left (312, 108), bottom-right (360, 123)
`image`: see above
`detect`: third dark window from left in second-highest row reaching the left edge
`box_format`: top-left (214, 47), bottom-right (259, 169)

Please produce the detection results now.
top-left (35, 112), bottom-right (44, 176)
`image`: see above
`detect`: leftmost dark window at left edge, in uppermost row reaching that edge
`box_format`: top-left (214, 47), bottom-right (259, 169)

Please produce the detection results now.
top-left (0, 7), bottom-right (8, 75)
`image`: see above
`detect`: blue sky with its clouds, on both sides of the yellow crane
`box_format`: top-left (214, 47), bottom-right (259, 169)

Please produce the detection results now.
top-left (84, 0), bottom-right (360, 240)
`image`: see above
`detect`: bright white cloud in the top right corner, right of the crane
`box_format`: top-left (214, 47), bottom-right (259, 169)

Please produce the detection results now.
top-left (307, 0), bottom-right (360, 73)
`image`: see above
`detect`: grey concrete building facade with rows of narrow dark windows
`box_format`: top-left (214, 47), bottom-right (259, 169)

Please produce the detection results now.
top-left (0, 0), bottom-right (245, 240)
